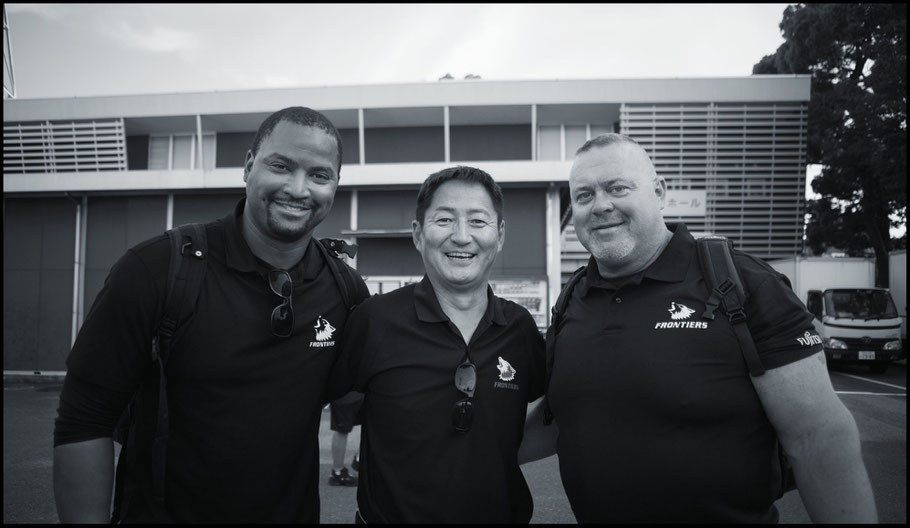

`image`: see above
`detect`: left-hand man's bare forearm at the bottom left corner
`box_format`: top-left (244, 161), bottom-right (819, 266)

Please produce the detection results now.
top-left (54, 438), bottom-right (114, 524)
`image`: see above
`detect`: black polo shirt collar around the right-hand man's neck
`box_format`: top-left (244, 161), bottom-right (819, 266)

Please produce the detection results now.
top-left (579, 223), bottom-right (695, 296)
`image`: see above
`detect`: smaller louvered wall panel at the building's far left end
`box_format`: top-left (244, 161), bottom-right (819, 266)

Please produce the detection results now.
top-left (3, 119), bottom-right (126, 174)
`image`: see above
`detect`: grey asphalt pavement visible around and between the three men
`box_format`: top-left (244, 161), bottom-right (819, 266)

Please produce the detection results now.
top-left (3, 364), bottom-right (907, 524)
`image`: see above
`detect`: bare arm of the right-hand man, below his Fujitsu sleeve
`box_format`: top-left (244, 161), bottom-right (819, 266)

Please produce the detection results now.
top-left (752, 352), bottom-right (878, 523)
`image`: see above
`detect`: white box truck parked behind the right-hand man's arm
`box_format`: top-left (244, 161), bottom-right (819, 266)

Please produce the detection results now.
top-left (768, 257), bottom-right (906, 373)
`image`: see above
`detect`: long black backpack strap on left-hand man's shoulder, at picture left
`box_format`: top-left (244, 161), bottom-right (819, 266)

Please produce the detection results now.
top-left (152, 224), bottom-right (208, 505)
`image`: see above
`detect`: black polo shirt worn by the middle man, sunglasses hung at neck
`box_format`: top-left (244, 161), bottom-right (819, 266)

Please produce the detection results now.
top-left (339, 277), bottom-right (546, 523)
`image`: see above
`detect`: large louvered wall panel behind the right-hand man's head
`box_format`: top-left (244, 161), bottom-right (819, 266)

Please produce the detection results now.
top-left (620, 103), bottom-right (807, 259)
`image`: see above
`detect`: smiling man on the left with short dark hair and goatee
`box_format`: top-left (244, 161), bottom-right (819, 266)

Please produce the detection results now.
top-left (54, 107), bottom-right (369, 523)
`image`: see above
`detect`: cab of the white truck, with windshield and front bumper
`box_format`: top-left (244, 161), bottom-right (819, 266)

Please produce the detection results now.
top-left (806, 288), bottom-right (906, 373)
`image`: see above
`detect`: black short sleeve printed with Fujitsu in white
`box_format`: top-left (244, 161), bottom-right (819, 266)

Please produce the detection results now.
top-left (743, 261), bottom-right (823, 369)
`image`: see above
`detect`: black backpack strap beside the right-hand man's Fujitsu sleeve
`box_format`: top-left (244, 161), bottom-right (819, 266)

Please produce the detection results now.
top-left (695, 236), bottom-right (765, 376)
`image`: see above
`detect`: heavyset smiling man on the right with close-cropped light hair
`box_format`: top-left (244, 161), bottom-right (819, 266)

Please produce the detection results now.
top-left (521, 134), bottom-right (876, 523)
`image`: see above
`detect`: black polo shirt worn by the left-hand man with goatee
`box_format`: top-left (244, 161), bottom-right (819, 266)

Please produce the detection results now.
top-left (55, 201), bottom-right (368, 523)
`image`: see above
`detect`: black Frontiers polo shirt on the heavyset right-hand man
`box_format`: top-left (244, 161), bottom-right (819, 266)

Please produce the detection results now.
top-left (548, 224), bottom-right (822, 523)
